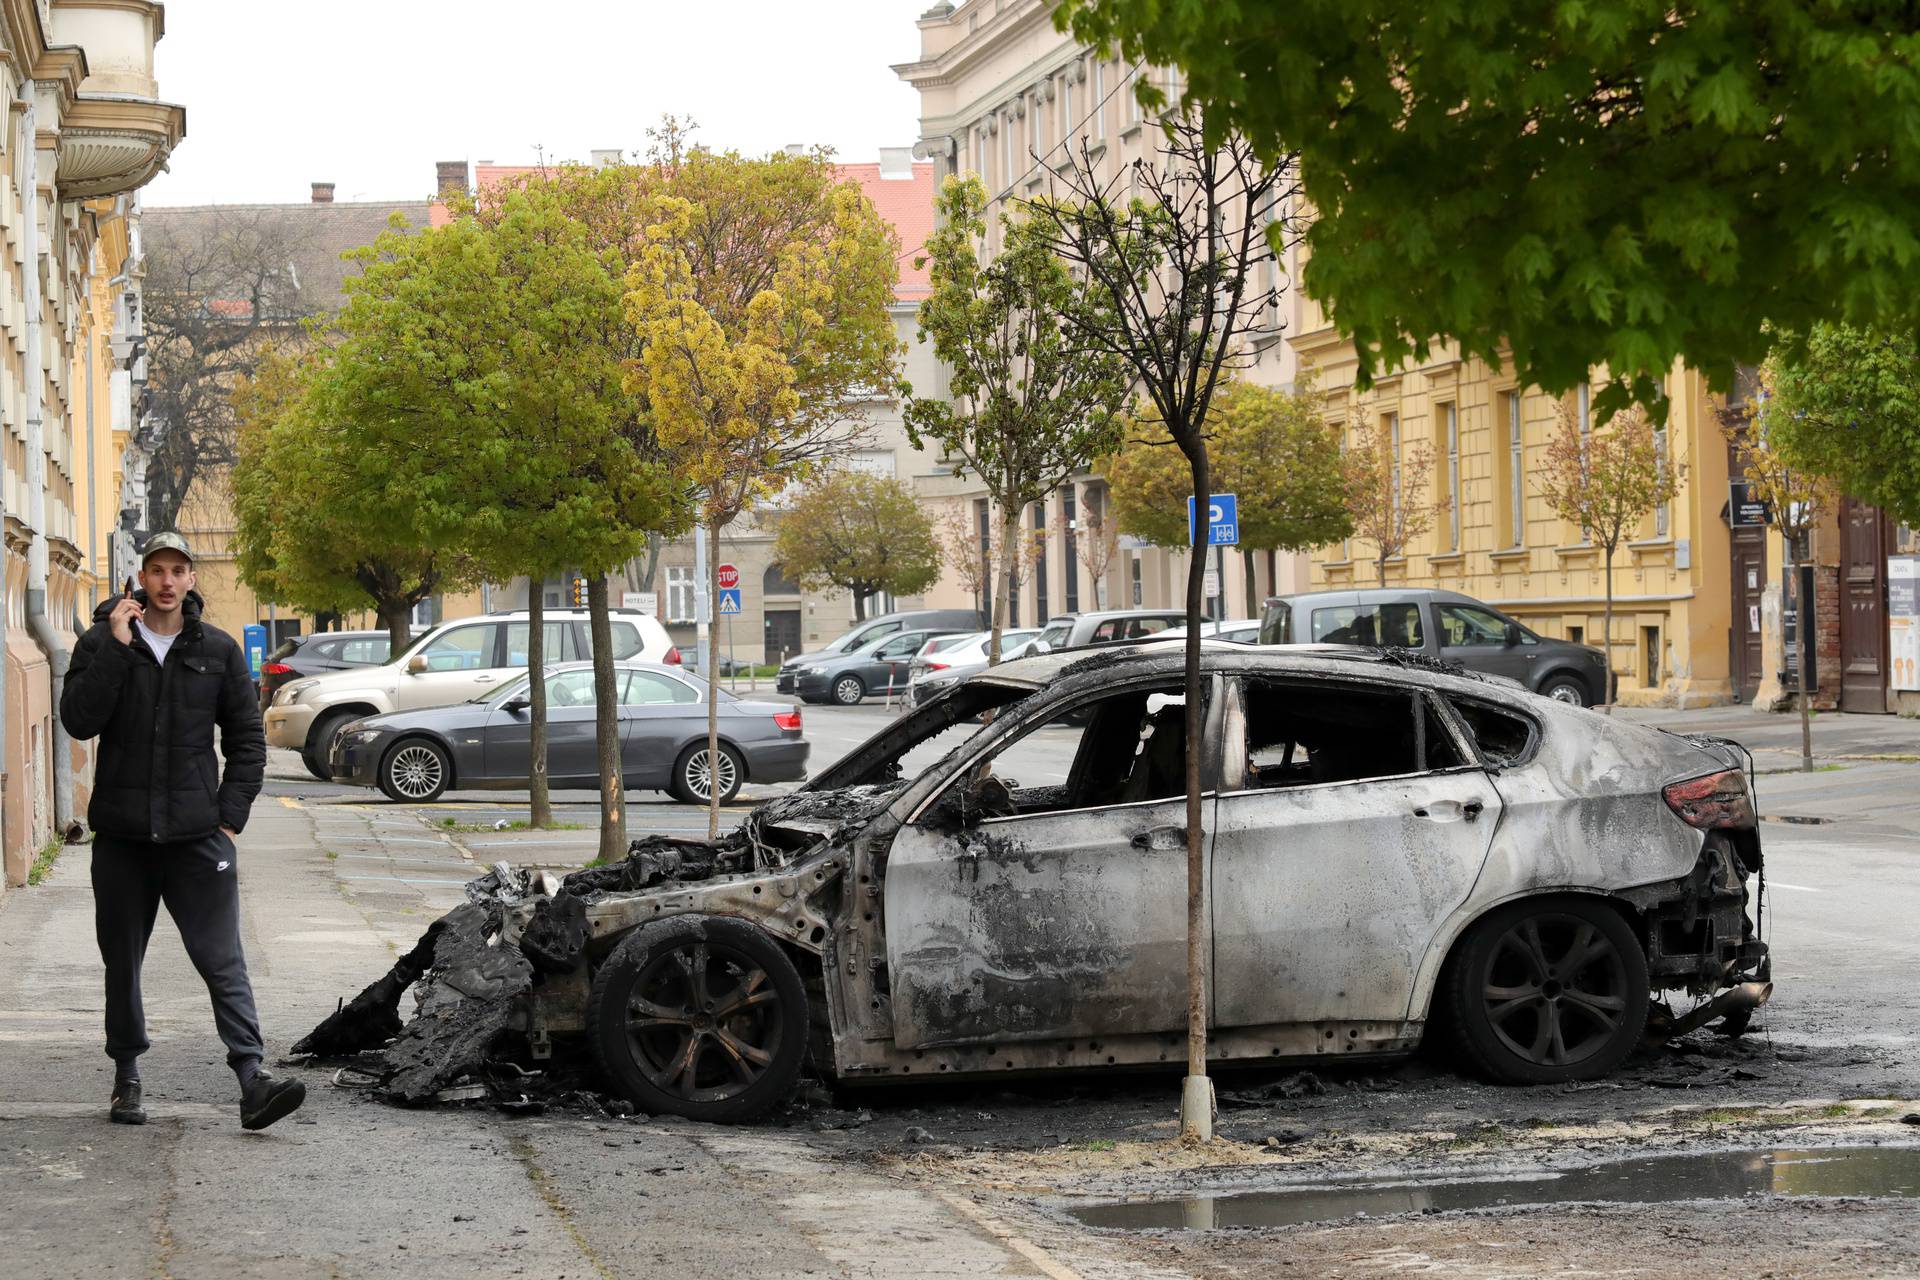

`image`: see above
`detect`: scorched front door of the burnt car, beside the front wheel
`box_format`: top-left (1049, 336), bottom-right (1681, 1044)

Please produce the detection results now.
top-left (881, 672), bottom-right (1223, 1050)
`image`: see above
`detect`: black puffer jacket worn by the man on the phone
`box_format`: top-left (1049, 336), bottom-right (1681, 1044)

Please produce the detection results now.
top-left (60, 591), bottom-right (267, 841)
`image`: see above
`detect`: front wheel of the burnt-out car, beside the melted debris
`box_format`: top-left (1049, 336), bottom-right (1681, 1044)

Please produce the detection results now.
top-left (588, 915), bottom-right (806, 1123)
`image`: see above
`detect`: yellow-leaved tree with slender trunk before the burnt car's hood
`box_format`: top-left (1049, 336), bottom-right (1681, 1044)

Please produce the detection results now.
top-left (626, 148), bottom-right (899, 835)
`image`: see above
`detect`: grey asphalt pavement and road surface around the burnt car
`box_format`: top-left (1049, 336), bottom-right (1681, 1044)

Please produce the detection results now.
top-left (0, 704), bottom-right (1920, 1280)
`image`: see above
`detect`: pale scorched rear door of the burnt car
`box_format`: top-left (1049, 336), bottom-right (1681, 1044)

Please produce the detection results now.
top-left (1208, 668), bottom-right (1505, 1028)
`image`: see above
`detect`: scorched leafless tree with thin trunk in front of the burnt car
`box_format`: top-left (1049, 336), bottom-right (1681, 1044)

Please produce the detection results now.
top-left (1031, 113), bottom-right (1298, 1140)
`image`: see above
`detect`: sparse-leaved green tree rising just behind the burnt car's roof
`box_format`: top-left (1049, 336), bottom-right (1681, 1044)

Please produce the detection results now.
top-left (906, 175), bottom-right (1127, 662)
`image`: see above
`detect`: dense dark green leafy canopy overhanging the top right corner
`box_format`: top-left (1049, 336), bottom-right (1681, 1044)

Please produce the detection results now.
top-left (1054, 0), bottom-right (1920, 411)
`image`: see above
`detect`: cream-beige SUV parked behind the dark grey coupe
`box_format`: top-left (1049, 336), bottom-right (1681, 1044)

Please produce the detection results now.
top-left (265, 608), bottom-right (680, 781)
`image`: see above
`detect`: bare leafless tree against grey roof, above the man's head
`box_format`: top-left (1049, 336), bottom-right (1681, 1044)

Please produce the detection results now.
top-left (142, 205), bottom-right (321, 530)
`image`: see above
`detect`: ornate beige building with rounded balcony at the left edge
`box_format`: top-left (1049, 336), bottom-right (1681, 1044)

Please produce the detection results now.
top-left (0, 0), bottom-right (186, 885)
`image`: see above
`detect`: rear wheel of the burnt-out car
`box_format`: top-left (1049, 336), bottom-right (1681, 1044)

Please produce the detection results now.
top-left (1448, 898), bottom-right (1649, 1084)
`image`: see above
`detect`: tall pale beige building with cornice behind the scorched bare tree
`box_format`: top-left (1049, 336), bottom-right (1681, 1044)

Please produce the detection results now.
top-left (895, 0), bottom-right (1308, 626)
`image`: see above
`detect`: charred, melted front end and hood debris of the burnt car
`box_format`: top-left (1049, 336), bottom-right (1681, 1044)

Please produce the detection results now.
top-left (294, 783), bottom-right (902, 1113)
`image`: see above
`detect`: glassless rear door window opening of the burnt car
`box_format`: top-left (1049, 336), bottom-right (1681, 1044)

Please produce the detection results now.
top-left (1244, 679), bottom-right (1467, 787)
